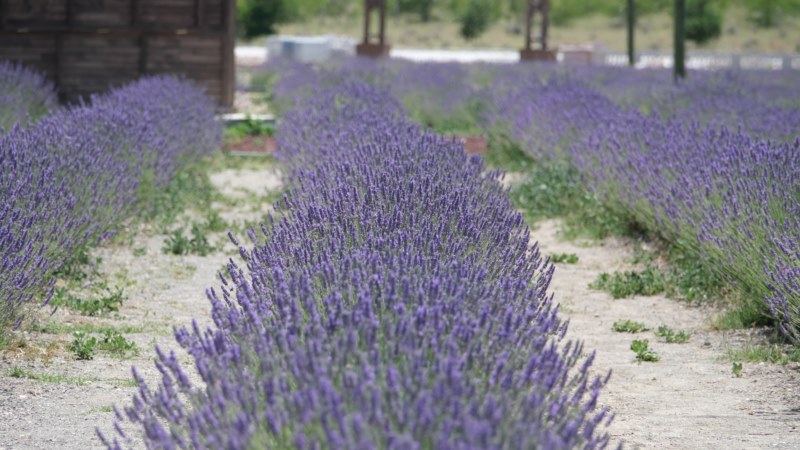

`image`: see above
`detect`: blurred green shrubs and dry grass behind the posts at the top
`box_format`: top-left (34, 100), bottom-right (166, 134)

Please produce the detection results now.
top-left (237, 0), bottom-right (800, 54)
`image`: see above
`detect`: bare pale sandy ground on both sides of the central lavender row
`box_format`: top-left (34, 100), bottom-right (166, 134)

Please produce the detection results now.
top-left (0, 162), bottom-right (800, 449)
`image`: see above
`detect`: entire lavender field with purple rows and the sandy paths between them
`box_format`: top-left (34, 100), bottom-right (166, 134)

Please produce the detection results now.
top-left (0, 59), bottom-right (800, 449)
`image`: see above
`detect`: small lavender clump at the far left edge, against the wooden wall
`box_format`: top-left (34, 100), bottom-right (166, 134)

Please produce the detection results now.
top-left (0, 61), bottom-right (58, 130)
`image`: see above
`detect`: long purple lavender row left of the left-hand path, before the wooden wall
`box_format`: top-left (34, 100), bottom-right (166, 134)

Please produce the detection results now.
top-left (0, 77), bottom-right (221, 325)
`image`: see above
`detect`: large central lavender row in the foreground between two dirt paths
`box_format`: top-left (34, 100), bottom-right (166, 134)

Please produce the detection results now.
top-left (101, 80), bottom-right (611, 449)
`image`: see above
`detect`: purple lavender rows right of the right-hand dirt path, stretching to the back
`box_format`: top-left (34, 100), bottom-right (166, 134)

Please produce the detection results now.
top-left (264, 61), bottom-right (800, 342)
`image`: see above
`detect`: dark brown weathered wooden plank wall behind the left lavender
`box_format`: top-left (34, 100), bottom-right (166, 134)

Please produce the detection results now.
top-left (0, 0), bottom-right (236, 107)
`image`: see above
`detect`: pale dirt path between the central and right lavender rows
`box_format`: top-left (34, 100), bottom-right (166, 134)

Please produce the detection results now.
top-left (533, 221), bottom-right (800, 449)
